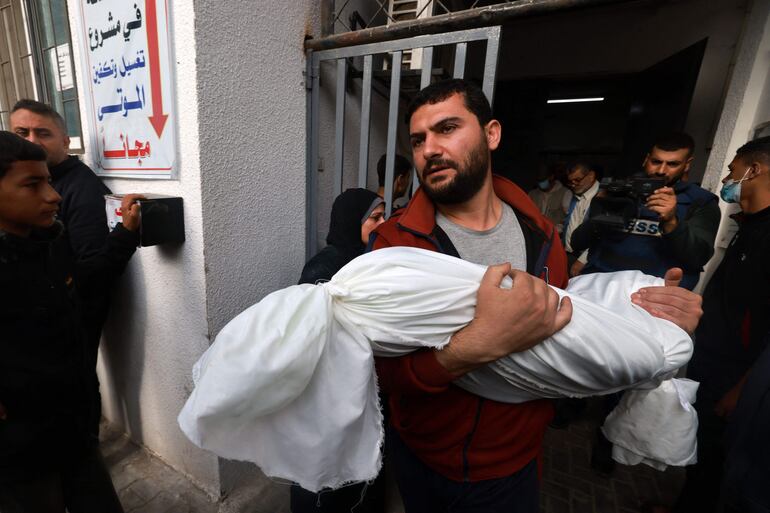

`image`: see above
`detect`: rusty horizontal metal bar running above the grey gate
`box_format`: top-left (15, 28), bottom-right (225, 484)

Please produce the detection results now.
top-left (305, 0), bottom-right (636, 53)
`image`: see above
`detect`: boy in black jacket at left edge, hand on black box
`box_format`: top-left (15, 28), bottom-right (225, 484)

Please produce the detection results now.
top-left (0, 132), bottom-right (139, 513)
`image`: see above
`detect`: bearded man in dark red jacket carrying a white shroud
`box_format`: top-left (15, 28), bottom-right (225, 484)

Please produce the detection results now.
top-left (372, 79), bottom-right (700, 513)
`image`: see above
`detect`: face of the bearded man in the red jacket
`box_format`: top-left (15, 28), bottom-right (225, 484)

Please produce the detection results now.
top-left (409, 94), bottom-right (500, 204)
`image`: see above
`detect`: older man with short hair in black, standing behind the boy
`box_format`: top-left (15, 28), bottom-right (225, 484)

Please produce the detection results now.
top-left (11, 100), bottom-right (110, 434)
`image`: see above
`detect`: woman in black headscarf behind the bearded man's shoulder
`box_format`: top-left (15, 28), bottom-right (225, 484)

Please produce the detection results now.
top-left (291, 189), bottom-right (385, 513)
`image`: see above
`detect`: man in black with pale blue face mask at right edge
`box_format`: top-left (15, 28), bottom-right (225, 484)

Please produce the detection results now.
top-left (662, 137), bottom-right (770, 513)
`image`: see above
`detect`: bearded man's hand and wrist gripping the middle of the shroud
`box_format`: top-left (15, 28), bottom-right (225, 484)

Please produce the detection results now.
top-left (436, 264), bottom-right (572, 377)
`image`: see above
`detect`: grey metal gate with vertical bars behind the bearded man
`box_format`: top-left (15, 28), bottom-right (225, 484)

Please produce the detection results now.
top-left (305, 26), bottom-right (508, 258)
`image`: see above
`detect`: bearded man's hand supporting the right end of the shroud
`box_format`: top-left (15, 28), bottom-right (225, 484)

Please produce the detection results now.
top-left (631, 267), bottom-right (703, 335)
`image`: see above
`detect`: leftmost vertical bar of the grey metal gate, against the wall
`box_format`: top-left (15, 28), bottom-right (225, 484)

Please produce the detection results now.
top-left (305, 52), bottom-right (321, 260)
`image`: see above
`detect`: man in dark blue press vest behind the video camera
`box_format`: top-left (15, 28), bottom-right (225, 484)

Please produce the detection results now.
top-left (570, 133), bottom-right (720, 290)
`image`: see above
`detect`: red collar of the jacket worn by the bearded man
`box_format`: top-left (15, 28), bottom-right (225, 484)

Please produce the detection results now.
top-left (398, 175), bottom-right (551, 236)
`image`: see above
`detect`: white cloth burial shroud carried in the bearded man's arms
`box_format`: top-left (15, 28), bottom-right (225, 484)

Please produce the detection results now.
top-left (179, 247), bottom-right (697, 491)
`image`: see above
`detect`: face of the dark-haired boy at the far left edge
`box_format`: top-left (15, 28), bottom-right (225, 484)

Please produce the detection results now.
top-left (0, 160), bottom-right (61, 237)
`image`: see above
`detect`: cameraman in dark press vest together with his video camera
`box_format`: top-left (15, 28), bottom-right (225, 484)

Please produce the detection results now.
top-left (570, 133), bottom-right (721, 474)
